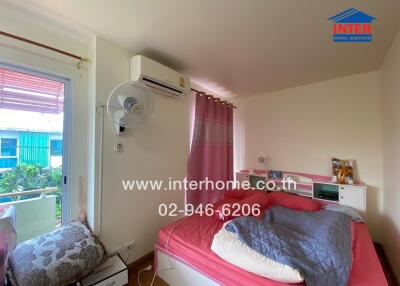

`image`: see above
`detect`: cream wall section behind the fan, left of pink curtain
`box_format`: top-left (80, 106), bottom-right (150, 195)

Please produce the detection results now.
top-left (96, 38), bottom-right (191, 261)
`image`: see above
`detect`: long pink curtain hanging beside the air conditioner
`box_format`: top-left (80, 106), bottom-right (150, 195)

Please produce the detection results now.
top-left (186, 93), bottom-right (233, 206)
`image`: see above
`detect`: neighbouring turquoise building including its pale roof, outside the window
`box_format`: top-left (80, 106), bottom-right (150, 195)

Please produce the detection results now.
top-left (0, 89), bottom-right (64, 171)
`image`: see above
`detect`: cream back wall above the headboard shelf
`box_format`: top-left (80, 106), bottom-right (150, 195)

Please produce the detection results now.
top-left (235, 72), bottom-right (382, 240)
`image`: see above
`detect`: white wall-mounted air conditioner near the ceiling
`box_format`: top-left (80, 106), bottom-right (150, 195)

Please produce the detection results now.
top-left (130, 55), bottom-right (190, 96)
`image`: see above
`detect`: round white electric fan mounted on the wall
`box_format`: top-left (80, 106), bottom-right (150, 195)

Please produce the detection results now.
top-left (107, 81), bottom-right (155, 135)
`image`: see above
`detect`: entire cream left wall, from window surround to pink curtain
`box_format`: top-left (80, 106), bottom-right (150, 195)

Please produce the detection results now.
top-left (0, 6), bottom-right (212, 261)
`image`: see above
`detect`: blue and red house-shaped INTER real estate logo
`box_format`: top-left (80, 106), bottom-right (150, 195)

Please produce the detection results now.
top-left (329, 8), bottom-right (376, 43)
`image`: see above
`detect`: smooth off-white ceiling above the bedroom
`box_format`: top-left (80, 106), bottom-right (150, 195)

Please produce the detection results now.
top-left (0, 0), bottom-right (400, 97)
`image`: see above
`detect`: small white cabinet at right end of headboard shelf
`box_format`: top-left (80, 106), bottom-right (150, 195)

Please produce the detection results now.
top-left (339, 185), bottom-right (367, 212)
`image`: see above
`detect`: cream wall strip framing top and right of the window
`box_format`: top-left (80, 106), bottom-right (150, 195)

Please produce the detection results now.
top-left (0, 6), bottom-right (89, 222)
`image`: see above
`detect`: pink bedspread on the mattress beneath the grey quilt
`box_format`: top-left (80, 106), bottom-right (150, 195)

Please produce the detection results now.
top-left (156, 209), bottom-right (388, 286)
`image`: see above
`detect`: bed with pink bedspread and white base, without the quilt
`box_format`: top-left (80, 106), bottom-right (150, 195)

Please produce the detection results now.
top-left (155, 194), bottom-right (388, 286)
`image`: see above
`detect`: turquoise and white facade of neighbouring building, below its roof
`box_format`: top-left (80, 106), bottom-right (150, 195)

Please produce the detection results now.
top-left (0, 129), bottom-right (63, 170)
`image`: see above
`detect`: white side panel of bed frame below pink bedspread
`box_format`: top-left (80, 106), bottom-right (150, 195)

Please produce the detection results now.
top-left (154, 246), bottom-right (221, 286)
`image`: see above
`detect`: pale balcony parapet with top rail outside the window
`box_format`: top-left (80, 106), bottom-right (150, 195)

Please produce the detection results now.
top-left (0, 188), bottom-right (59, 242)
